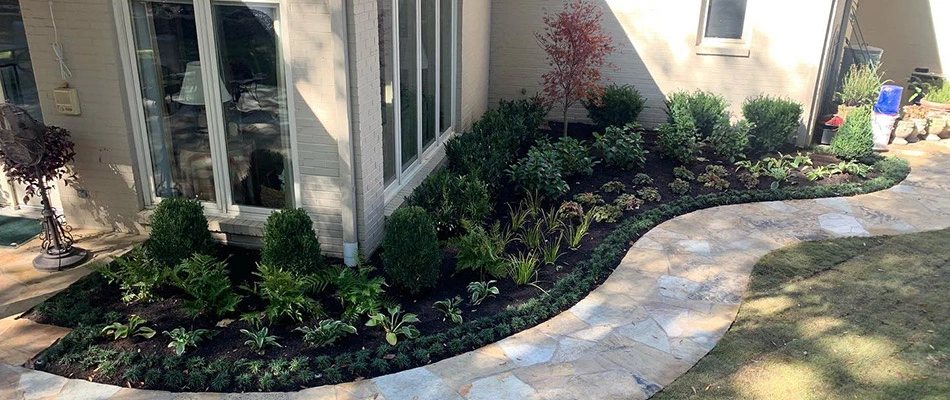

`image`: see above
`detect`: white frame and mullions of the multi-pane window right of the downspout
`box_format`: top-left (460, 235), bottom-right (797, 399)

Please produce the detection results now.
top-left (384, 0), bottom-right (459, 204)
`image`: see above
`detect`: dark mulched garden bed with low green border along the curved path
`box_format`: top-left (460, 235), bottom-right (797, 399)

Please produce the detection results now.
top-left (25, 123), bottom-right (907, 391)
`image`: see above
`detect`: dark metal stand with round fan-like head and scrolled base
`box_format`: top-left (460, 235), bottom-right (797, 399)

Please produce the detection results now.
top-left (0, 103), bottom-right (89, 272)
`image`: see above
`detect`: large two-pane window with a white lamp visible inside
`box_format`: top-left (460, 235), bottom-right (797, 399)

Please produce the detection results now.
top-left (128, 0), bottom-right (294, 210)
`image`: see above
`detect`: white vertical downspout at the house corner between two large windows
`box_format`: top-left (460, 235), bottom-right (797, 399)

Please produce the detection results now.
top-left (330, 0), bottom-right (359, 267)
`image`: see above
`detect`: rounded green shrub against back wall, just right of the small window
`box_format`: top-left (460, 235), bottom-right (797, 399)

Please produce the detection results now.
top-left (742, 95), bottom-right (802, 154)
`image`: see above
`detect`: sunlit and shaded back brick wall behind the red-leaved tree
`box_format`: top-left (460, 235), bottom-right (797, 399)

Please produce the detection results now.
top-left (489, 0), bottom-right (832, 135)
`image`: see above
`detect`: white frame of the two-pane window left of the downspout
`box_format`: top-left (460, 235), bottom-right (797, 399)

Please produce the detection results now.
top-left (112, 0), bottom-right (301, 217)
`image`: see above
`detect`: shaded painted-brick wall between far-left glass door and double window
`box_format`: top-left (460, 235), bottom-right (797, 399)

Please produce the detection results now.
top-left (20, 0), bottom-right (140, 232)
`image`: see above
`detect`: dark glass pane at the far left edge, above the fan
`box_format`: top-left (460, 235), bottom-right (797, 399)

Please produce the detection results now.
top-left (0, 1), bottom-right (43, 122)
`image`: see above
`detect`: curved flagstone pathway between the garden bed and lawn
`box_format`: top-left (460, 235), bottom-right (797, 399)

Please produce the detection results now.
top-left (0, 143), bottom-right (950, 400)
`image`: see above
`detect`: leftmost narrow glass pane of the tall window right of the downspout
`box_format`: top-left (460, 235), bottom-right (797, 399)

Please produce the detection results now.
top-left (377, 0), bottom-right (396, 186)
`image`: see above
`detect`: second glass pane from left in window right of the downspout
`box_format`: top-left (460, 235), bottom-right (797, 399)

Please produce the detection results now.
top-left (398, 0), bottom-right (419, 169)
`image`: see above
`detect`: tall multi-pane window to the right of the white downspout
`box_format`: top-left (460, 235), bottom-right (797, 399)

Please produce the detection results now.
top-left (378, 0), bottom-right (457, 192)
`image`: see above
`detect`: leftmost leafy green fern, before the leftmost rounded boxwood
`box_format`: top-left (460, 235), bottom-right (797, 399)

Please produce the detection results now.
top-left (93, 246), bottom-right (168, 303)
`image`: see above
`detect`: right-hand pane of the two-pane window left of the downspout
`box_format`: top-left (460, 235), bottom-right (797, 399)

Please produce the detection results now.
top-left (214, 3), bottom-right (293, 208)
